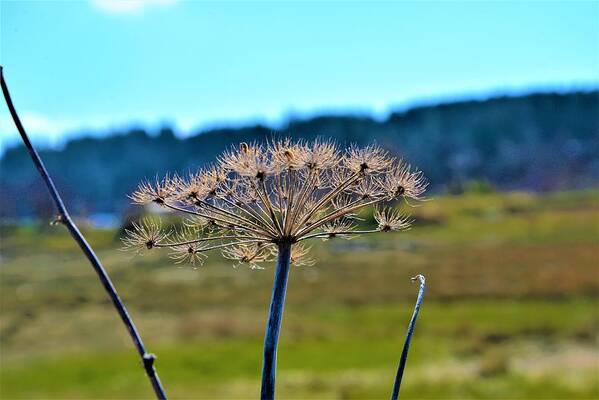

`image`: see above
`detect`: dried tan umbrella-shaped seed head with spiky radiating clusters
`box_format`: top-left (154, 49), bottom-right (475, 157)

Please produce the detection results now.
top-left (124, 139), bottom-right (427, 268)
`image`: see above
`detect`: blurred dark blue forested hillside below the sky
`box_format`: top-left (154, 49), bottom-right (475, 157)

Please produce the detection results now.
top-left (0, 91), bottom-right (599, 217)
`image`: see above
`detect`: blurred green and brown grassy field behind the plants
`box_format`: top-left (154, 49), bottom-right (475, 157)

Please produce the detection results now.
top-left (0, 191), bottom-right (599, 399)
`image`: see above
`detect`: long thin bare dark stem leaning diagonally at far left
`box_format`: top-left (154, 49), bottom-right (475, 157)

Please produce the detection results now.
top-left (0, 66), bottom-right (166, 399)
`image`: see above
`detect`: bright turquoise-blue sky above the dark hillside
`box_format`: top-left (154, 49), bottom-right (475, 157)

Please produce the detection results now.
top-left (0, 0), bottom-right (599, 148)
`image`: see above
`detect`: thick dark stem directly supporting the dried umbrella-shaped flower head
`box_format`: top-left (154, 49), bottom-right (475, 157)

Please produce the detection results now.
top-left (260, 242), bottom-right (291, 400)
